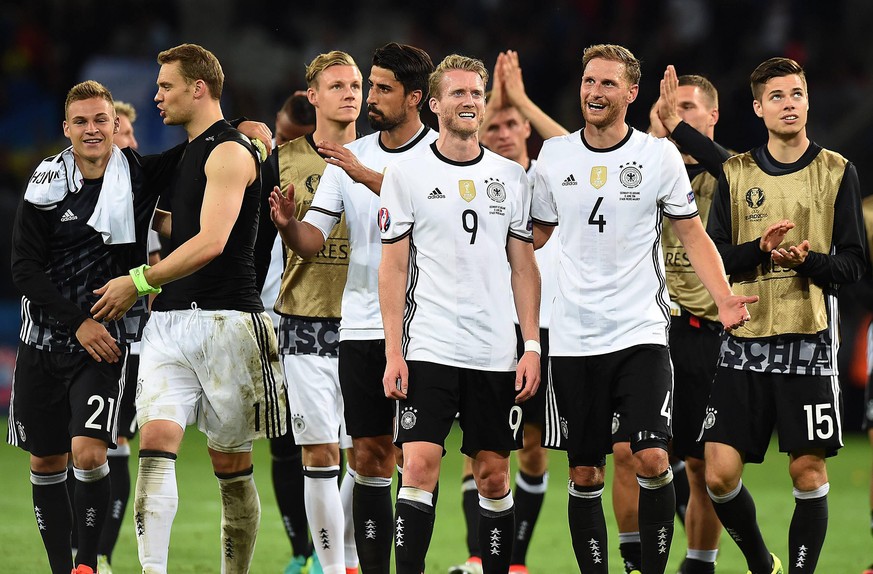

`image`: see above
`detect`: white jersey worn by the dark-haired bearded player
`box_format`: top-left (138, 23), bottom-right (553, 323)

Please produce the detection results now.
top-left (303, 126), bottom-right (438, 341)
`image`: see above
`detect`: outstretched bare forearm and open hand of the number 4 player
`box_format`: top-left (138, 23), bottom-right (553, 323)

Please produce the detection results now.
top-left (670, 217), bottom-right (758, 331)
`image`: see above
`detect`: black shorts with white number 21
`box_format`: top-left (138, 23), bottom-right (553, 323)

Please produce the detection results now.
top-left (7, 342), bottom-right (127, 457)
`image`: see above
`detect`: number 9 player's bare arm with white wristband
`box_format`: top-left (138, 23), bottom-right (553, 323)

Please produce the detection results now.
top-left (504, 237), bottom-right (541, 403)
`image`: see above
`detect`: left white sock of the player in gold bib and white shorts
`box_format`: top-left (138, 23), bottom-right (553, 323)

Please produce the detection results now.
top-left (303, 466), bottom-right (346, 574)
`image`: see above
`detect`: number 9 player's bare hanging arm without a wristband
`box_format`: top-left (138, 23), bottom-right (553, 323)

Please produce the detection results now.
top-left (379, 237), bottom-right (410, 399)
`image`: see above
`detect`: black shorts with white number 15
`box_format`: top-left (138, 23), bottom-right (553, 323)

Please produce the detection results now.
top-left (701, 367), bottom-right (843, 463)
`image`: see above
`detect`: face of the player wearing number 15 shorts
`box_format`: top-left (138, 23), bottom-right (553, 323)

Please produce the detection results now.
top-left (752, 74), bottom-right (809, 139)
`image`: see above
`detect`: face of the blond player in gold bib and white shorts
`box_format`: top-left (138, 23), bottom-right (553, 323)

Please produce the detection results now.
top-left (307, 65), bottom-right (363, 124)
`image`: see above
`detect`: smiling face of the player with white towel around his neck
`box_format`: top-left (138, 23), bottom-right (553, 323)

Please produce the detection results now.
top-left (64, 97), bottom-right (118, 162)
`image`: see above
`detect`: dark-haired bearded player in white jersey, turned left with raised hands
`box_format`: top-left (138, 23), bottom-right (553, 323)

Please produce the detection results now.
top-left (270, 42), bottom-right (437, 574)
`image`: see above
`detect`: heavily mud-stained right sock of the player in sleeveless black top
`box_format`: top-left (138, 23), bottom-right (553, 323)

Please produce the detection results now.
top-left (215, 468), bottom-right (261, 574)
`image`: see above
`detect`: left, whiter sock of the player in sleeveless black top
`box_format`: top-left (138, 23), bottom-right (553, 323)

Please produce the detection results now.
top-left (133, 451), bottom-right (179, 574)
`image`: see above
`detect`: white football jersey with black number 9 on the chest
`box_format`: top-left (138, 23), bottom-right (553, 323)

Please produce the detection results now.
top-left (379, 144), bottom-right (532, 371)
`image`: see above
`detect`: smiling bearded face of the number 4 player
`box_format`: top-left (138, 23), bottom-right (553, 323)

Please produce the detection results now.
top-left (579, 58), bottom-right (639, 129)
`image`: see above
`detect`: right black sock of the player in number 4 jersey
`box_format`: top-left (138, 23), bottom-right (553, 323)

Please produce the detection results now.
top-left (637, 468), bottom-right (676, 572)
